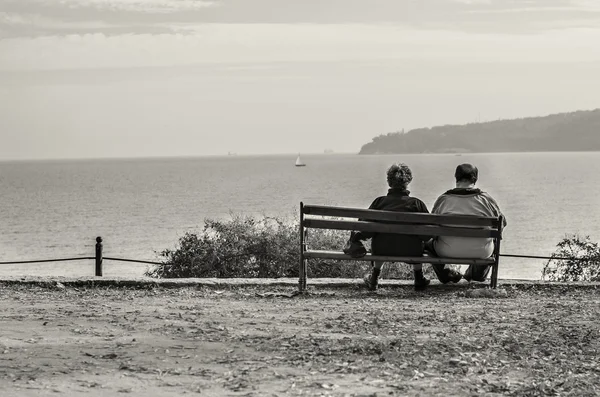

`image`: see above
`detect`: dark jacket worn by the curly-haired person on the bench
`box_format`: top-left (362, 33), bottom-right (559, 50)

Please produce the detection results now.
top-left (361, 188), bottom-right (429, 256)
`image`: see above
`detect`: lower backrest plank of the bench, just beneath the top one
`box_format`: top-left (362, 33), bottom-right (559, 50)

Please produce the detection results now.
top-left (303, 218), bottom-right (500, 238)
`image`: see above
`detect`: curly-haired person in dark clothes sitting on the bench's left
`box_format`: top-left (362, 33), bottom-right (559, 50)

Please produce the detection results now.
top-left (344, 163), bottom-right (430, 291)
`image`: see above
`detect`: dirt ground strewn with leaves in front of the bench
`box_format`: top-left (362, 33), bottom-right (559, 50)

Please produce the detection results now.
top-left (0, 284), bottom-right (600, 397)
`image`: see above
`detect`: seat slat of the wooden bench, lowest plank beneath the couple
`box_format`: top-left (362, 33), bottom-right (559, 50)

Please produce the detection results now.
top-left (304, 250), bottom-right (494, 265)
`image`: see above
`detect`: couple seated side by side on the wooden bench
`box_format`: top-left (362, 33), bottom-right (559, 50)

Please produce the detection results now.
top-left (344, 163), bottom-right (506, 290)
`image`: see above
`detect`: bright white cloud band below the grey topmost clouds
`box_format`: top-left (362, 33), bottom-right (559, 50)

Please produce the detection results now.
top-left (0, 24), bottom-right (600, 70)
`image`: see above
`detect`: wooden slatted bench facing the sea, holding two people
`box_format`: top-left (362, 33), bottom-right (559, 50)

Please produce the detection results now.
top-left (298, 203), bottom-right (503, 292)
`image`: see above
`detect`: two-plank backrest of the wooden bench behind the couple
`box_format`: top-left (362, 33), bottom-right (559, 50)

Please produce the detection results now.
top-left (300, 203), bottom-right (502, 239)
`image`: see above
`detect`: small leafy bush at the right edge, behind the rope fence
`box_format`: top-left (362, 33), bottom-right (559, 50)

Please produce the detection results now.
top-left (542, 234), bottom-right (600, 281)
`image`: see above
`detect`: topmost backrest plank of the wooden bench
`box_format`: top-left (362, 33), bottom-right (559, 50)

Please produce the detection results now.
top-left (303, 205), bottom-right (499, 228)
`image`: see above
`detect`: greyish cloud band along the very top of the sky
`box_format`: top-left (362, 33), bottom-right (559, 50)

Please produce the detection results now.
top-left (0, 0), bottom-right (600, 37)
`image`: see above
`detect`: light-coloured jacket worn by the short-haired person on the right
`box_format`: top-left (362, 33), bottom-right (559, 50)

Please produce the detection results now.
top-left (431, 188), bottom-right (506, 259)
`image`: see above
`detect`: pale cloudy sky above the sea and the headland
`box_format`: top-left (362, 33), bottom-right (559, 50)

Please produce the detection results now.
top-left (0, 0), bottom-right (600, 160)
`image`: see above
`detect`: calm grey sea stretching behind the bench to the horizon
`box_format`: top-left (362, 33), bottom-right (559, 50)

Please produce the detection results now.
top-left (0, 152), bottom-right (600, 279)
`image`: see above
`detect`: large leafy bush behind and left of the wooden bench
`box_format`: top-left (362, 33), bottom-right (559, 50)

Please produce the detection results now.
top-left (146, 215), bottom-right (429, 279)
